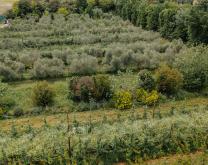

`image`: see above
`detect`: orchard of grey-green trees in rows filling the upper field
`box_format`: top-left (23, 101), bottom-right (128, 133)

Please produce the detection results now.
top-left (0, 14), bottom-right (183, 81)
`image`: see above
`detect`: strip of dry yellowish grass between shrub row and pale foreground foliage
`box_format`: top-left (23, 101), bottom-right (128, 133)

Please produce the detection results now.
top-left (0, 97), bottom-right (208, 131)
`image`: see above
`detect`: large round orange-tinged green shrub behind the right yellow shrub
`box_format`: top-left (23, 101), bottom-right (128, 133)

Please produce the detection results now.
top-left (156, 65), bottom-right (183, 95)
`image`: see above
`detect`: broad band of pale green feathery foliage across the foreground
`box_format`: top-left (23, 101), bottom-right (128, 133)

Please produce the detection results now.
top-left (0, 107), bottom-right (208, 164)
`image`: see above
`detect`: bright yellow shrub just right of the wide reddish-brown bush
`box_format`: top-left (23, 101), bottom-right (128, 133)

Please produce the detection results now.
top-left (113, 89), bottom-right (133, 109)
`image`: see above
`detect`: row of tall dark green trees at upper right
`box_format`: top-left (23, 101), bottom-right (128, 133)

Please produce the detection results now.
top-left (115, 0), bottom-right (208, 43)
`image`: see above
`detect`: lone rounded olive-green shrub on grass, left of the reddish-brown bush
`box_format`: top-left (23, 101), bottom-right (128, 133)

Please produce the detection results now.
top-left (32, 81), bottom-right (55, 107)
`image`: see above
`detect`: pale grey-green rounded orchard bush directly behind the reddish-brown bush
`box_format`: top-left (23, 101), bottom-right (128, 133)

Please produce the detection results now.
top-left (70, 56), bottom-right (98, 75)
